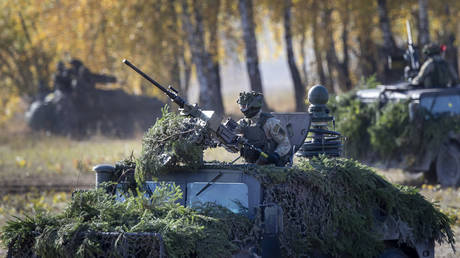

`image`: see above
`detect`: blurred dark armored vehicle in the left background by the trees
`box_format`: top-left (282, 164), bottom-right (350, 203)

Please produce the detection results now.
top-left (26, 59), bottom-right (164, 137)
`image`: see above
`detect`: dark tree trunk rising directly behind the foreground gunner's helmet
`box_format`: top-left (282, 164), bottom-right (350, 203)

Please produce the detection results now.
top-left (238, 0), bottom-right (267, 107)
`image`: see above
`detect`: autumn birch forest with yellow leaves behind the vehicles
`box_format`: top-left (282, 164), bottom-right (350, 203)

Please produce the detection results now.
top-left (0, 0), bottom-right (460, 121)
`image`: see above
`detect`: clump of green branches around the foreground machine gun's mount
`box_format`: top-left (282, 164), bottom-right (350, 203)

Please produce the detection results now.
top-left (136, 107), bottom-right (214, 182)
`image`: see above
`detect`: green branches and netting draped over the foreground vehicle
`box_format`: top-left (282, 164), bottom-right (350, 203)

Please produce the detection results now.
top-left (2, 157), bottom-right (455, 257)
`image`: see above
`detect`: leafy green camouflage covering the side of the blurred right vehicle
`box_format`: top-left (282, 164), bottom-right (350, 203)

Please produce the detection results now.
top-left (331, 94), bottom-right (460, 161)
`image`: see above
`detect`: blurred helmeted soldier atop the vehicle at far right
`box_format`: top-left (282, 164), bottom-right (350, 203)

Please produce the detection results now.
top-left (411, 43), bottom-right (457, 88)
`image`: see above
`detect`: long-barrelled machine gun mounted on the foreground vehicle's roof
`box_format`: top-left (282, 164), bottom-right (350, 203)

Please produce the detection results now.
top-left (123, 59), bottom-right (269, 158)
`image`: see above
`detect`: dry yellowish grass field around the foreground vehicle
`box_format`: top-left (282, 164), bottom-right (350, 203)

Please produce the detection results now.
top-left (0, 133), bottom-right (460, 257)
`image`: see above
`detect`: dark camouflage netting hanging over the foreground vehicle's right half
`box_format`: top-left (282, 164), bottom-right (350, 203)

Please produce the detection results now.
top-left (246, 157), bottom-right (455, 257)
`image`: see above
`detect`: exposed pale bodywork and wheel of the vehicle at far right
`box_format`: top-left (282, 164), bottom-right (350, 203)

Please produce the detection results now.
top-left (356, 82), bottom-right (460, 186)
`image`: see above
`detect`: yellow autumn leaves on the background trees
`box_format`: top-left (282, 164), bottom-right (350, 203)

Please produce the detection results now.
top-left (0, 0), bottom-right (460, 124)
